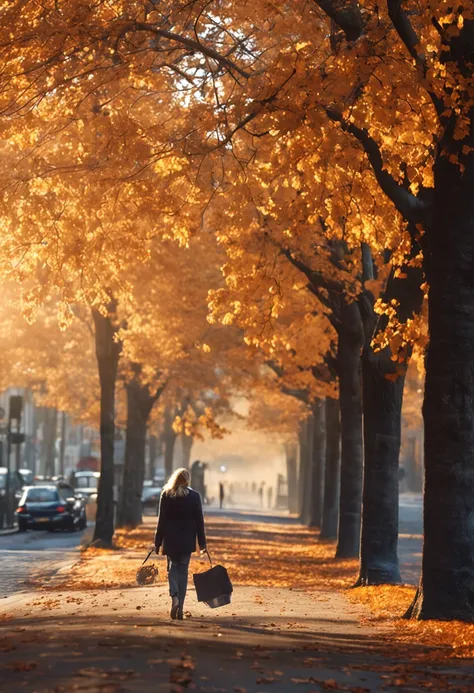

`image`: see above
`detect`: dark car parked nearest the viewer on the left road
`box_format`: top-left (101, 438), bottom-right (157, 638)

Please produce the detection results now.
top-left (16, 485), bottom-right (87, 532)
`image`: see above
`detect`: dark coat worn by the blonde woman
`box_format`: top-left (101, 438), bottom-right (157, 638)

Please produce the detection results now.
top-left (155, 488), bottom-right (206, 556)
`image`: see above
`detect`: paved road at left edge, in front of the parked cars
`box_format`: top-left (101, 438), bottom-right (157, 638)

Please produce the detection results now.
top-left (0, 531), bottom-right (82, 599)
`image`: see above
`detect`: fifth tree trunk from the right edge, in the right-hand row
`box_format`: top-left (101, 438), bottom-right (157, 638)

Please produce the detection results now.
top-left (307, 399), bottom-right (326, 527)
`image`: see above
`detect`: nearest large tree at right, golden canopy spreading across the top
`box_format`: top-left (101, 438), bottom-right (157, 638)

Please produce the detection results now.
top-left (1, 0), bottom-right (474, 620)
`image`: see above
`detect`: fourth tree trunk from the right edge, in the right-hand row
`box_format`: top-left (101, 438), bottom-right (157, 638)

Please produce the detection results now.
top-left (320, 397), bottom-right (341, 539)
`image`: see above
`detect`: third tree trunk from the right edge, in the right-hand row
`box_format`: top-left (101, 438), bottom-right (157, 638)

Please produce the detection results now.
top-left (336, 302), bottom-right (364, 558)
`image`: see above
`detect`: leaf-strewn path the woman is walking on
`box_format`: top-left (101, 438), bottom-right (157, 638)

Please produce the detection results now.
top-left (0, 510), bottom-right (474, 693)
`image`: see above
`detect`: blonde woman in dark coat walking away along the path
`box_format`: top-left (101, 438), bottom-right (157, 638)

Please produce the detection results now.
top-left (155, 468), bottom-right (206, 619)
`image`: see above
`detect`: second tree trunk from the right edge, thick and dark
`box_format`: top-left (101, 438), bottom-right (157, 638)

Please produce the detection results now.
top-left (358, 258), bottom-right (423, 585)
